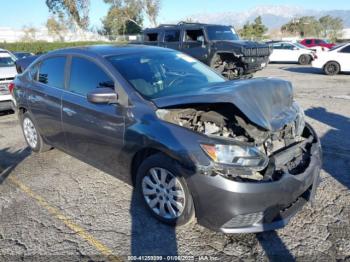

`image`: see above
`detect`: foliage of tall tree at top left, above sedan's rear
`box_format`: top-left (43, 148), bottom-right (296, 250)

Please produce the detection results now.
top-left (46, 0), bottom-right (90, 30)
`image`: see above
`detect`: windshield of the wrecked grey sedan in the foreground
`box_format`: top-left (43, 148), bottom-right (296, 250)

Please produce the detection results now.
top-left (108, 52), bottom-right (226, 99)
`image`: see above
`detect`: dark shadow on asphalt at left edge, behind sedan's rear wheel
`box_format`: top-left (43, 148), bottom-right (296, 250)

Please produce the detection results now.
top-left (0, 147), bottom-right (31, 184)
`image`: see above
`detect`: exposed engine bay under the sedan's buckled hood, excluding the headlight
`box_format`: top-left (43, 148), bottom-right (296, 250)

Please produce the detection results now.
top-left (157, 104), bottom-right (314, 181)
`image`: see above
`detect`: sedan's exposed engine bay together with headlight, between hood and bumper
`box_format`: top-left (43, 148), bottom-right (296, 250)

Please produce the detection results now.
top-left (156, 102), bottom-right (316, 182)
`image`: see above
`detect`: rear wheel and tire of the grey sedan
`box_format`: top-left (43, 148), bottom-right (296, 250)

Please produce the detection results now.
top-left (20, 112), bottom-right (51, 153)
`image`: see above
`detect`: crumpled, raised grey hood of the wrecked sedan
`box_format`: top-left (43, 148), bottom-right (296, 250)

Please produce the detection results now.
top-left (152, 78), bottom-right (298, 131)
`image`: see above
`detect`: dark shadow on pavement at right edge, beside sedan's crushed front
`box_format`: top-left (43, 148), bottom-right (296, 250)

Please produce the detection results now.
top-left (305, 107), bottom-right (350, 189)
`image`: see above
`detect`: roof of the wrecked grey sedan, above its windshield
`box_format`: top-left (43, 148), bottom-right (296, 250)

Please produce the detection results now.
top-left (47, 44), bottom-right (174, 57)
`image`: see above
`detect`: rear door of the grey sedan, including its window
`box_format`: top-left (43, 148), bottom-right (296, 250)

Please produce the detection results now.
top-left (28, 56), bottom-right (67, 147)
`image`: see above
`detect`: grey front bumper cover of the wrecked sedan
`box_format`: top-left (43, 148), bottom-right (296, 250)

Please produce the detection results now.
top-left (188, 128), bottom-right (322, 233)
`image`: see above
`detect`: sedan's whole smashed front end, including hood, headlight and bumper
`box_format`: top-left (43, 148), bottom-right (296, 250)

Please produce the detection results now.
top-left (154, 78), bottom-right (321, 233)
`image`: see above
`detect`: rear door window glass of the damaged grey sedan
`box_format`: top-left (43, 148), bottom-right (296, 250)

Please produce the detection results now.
top-left (37, 56), bottom-right (66, 89)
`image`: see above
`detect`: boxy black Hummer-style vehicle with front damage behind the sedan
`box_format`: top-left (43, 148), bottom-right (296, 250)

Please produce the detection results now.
top-left (142, 22), bottom-right (272, 79)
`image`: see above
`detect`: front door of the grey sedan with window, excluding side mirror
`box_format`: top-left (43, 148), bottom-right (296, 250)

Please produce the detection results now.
top-left (62, 56), bottom-right (124, 169)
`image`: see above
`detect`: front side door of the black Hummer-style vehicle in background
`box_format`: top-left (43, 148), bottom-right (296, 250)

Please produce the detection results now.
top-left (181, 27), bottom-right (208, 63)
